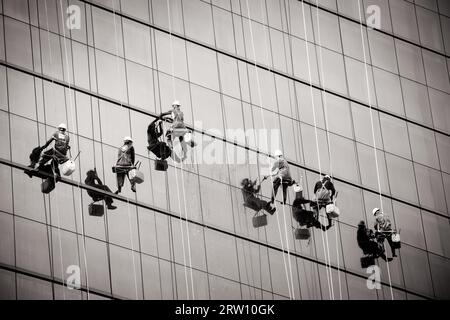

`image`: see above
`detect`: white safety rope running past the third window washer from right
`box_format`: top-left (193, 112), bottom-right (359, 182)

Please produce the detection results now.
top-left (246, 0), bottom-right (295, 300)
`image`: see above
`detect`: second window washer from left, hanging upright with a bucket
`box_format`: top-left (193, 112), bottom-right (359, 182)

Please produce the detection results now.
top-left (113, 137), bottom-right (136, 194)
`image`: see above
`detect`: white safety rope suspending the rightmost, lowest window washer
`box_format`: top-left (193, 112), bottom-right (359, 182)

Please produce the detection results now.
top-left (358, 0), bottom-right (394, 300)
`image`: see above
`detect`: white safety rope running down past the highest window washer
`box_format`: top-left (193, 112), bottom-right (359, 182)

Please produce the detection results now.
top-left (166, 0), bottom-right (194, 299)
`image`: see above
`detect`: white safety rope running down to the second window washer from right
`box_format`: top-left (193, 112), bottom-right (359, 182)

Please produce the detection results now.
top-left (302, 0), bottom-right (334, 300)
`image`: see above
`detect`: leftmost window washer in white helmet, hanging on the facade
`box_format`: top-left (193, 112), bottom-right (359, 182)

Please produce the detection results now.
top-left (35, 123), bottom-right (70, 170)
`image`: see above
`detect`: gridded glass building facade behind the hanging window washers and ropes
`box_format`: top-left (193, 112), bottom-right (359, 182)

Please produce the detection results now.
top-left (0, 0), bottom-right (450, 299)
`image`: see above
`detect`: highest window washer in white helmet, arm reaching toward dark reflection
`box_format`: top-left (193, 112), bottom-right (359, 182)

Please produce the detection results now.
top-left (161, 100), bottom-right (195, 161)
